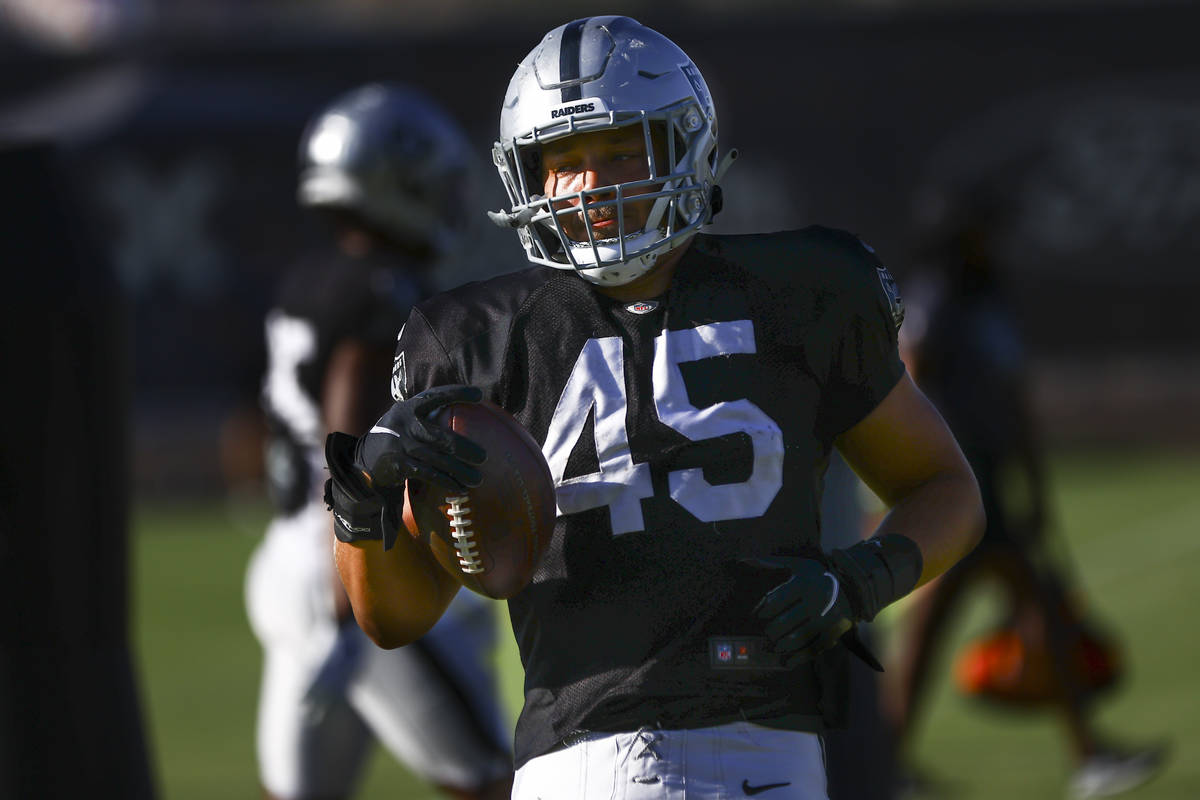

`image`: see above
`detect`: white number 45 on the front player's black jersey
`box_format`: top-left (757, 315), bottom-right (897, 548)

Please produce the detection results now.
top-left (542, 319), bottom-right (784, 534)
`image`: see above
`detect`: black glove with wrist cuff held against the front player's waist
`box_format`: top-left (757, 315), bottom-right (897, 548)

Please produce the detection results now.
top-left (754, 534), bottom-right (922, 672)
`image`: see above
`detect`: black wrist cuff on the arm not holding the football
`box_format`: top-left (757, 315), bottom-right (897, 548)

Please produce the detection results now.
top-left (829, 534), bottom-right (924, 622)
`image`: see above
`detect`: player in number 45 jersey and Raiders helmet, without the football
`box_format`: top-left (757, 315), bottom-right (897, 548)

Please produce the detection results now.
top-left (326, 17), bottom-right (983, 799)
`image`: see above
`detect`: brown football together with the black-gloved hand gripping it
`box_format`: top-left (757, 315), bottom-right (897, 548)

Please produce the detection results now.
top-left (325, 385), bottom-right (556, 597)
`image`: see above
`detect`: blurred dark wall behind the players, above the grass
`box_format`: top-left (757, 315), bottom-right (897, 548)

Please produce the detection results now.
top-left (0, 0), bottom-right (1200, 495)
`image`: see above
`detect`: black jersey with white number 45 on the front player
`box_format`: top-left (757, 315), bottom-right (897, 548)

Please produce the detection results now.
top-left (392, 228), bottom-right (904, 765)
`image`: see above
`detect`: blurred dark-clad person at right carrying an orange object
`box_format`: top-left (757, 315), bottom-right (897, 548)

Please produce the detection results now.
top-left (888, 191), bottom-right (1163, 798)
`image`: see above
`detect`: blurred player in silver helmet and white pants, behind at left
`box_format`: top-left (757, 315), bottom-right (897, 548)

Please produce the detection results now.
top-left (246, 84), bottom-right (512, 800)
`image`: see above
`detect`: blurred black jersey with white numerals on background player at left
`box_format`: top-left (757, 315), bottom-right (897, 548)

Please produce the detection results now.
top-left (260, 255), bottom-right (428, 512)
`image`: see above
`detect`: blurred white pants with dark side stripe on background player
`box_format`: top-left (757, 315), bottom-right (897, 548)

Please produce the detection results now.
top-left (246, 504), bottom-right (512, 798)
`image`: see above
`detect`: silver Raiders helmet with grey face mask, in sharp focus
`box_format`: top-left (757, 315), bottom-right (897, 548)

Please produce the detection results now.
top-left (488, 17), bottom-right (737, 285)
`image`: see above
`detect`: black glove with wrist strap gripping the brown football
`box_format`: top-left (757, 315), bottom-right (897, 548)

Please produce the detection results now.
top-left (325, 385), bottom-right (486, 549)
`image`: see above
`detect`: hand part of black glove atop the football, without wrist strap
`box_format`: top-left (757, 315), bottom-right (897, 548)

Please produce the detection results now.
top-left (354, 385), bottom-right (487, 495)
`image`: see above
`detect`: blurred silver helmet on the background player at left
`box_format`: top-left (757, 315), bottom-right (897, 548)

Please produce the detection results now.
top-left (298, 83), bottom-right (473, 255)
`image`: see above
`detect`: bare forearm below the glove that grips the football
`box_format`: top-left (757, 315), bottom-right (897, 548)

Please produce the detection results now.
top-left (334, 527), bottom-right (458, 649)
